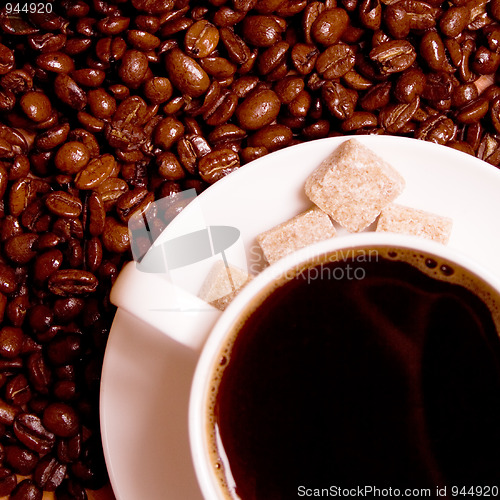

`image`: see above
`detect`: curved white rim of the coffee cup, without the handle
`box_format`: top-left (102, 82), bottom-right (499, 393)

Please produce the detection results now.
top-left (188, 232), bottom-right (500, 500)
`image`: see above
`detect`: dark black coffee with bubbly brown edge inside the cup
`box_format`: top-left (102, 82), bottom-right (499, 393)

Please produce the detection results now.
top-left (208, 249), bottom-right (500, 500)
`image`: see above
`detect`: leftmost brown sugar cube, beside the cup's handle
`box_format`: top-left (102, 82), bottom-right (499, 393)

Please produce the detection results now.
top-left (198, 260), bottom-right (252, 311)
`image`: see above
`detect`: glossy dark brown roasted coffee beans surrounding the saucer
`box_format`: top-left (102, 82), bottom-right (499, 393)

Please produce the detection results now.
top-left (0, 0), bottom-right (500, 500)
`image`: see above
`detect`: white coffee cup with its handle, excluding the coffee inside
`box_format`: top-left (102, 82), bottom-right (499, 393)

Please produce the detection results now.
top-left (111, 232), bottom-right (500, 500)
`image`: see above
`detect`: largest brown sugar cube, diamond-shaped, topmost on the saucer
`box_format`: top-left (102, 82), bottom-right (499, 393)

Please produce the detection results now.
top-left (305, 139), bottom-right (405, 232)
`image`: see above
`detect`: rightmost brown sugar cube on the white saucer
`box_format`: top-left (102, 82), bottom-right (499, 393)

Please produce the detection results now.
top-left (376, 203), bottom-right (453, 244)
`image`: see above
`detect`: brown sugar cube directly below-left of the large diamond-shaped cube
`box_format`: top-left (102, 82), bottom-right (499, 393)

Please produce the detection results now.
top-left (257, 207), bottom-right (336, 264)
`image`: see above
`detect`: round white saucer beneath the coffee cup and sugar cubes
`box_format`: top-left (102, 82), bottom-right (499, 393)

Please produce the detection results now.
top-left (100, 136), bottom-right (500, 500)
